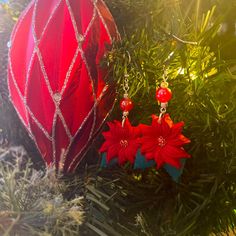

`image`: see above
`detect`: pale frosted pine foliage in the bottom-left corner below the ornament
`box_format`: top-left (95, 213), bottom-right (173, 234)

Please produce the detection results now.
top-left (0, 147), bottom-right (84, 236)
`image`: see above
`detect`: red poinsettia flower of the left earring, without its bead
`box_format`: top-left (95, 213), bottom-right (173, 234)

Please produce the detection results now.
top-left (99, 118), bottom-right (140, 165)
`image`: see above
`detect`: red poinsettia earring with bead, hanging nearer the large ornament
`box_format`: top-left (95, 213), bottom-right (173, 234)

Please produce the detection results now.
top-left (100, 74), bottom-right (140, 166)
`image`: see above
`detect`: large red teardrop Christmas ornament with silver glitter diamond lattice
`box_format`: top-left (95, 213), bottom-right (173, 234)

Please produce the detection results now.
top-left (8, 0), bottom-right (119, 172)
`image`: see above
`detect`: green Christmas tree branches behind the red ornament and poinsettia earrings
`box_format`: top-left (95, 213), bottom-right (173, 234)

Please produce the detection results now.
top-left (0, 0), bottom-right (236, 236)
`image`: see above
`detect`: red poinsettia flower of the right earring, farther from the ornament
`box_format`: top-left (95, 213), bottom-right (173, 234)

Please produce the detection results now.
top-left (139, 114), bottom-right (190, 169)
